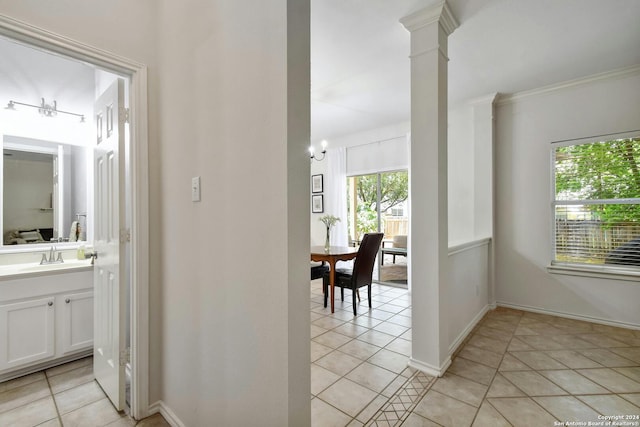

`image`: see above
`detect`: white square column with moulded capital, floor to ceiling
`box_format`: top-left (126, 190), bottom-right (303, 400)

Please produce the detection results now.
top-left (400, 2), bottom-right (458, 376)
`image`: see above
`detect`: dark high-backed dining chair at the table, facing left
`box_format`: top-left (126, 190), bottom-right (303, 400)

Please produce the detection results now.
top-left (322, 233), bottom-right (383, 316)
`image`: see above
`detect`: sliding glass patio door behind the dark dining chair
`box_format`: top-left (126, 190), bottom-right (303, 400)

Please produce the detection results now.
top-left (347, 170), bottom-right (409, 286)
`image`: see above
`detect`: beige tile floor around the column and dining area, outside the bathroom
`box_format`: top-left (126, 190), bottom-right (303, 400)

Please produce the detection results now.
top-left (310, 280), bottom-right (640, 427)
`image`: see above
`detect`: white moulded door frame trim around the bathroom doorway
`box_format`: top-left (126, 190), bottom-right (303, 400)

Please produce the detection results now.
top-left (0, 16), bottom-right (149, 419)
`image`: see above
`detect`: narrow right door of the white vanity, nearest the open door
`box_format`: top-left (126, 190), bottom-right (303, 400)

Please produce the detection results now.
top-left (61, 291), bottom-right (93, 354)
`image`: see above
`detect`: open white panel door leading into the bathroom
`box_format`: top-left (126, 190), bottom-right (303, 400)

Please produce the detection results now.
top-left (93, 79), bottom-right (126, 410)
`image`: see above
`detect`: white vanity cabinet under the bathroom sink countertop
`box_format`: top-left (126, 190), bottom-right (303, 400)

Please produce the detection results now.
top-left (0, 266), bottom-right (93, 381)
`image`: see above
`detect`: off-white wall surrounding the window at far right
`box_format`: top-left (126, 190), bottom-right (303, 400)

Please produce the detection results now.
top-left (495, 69), bottom-right (640, 327)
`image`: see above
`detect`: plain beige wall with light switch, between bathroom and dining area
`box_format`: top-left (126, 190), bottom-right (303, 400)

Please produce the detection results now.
top-left (0, 0), bottom-right (310, 426)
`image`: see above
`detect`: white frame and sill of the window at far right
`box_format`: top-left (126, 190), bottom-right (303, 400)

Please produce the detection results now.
top-left (547, 130), bottom-right (640, 281)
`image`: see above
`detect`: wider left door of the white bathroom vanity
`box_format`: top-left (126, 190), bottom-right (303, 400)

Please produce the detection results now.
top-left (0, 297), bottom-right (55, 371)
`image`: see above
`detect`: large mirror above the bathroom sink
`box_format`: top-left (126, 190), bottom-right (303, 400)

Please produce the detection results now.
top-left (2, 135), bottom-right (93, 248)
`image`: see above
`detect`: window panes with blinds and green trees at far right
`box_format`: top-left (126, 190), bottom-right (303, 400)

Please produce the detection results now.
top-left (552, 138), bottom-right (640, 267)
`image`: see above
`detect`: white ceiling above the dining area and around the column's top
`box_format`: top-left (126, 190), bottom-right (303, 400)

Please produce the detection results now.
top-left (311, 0), bottom-right (640, 142)
